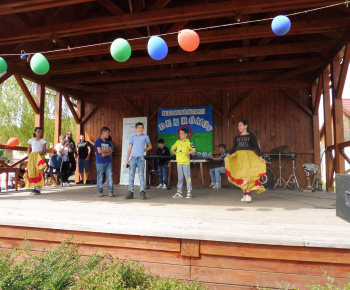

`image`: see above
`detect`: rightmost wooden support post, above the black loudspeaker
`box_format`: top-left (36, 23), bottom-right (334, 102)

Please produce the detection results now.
top-left (331, 57), bottom-right (347, 173)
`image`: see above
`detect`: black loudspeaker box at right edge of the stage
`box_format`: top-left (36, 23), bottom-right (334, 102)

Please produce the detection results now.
top-left (335, 174), bottom-right (350, 222)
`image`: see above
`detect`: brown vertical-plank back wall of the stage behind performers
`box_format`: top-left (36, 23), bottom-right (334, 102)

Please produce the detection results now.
top-left (84, 88), bottom-right (314, 186)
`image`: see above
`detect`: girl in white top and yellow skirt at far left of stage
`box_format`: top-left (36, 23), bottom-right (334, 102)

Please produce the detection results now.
top-left (23, 127), bottom-right (47, 195)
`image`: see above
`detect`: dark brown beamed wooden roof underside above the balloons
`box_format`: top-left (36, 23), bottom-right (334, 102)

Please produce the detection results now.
top-left (0, 0), bottom-right (350, 98)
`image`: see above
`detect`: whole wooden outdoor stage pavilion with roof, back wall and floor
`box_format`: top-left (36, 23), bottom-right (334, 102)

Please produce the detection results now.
top-left (0, 0), bottom-right (350, 289)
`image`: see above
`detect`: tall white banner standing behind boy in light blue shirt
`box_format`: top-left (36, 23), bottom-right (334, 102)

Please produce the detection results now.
top-left (119, 117), bottom-right (147, 185)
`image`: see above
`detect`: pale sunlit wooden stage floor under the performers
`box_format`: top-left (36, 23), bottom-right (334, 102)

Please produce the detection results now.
top-left (0, 185), bottom-right (350, 249)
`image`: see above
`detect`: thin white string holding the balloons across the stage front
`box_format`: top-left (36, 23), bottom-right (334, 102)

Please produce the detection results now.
top-left (0, 0), bottom-right (349, 56)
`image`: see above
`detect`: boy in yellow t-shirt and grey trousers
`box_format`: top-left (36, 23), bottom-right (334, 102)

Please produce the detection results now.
top-left (171, 128), bottom-right (196, 198)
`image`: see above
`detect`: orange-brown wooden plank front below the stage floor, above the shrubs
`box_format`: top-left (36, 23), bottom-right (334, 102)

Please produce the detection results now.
top-left (0, 225), bottom-right (350, 289)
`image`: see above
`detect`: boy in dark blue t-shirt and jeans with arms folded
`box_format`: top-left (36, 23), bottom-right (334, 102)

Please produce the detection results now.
top-left (95, 127), bottom-right (114, 197)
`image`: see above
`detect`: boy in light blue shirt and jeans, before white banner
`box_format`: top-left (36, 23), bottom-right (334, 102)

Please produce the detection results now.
top-left (125, 122), bottom-right (152, 200)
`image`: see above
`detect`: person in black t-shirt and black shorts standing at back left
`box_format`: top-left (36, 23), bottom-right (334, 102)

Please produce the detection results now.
top-left (76, 134), bottom-right (91, 184)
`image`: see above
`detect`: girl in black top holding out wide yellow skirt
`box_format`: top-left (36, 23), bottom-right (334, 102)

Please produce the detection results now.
top-left (225, 120), bottom-right (266, 202)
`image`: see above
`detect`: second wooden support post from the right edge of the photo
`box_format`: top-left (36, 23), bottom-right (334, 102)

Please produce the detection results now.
top-left (323, 67), bottom-right (334, 191)
